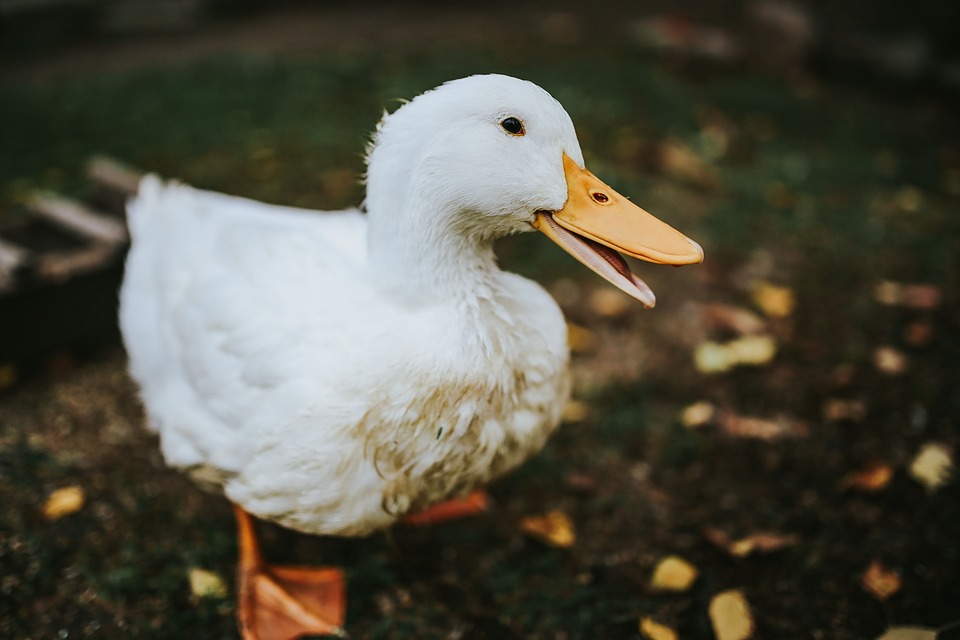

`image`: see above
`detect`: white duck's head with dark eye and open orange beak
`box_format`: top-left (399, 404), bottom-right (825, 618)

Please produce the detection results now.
top-left (366, 75), bottom-right (703, 307)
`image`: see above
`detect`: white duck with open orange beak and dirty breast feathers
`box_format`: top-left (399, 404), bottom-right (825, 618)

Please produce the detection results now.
top-left (120, 75), bottom-right (703, 639)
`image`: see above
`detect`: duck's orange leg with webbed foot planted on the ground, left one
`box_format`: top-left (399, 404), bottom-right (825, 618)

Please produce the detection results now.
top-left (234, 505), bottom-right (346, 640)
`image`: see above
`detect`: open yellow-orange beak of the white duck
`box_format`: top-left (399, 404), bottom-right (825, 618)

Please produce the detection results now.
top-left (533, 153), bottom-right (703, 308)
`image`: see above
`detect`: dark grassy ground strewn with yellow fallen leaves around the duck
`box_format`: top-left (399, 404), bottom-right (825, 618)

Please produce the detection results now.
top-left (0, 6), bottom-right (960, 640)
